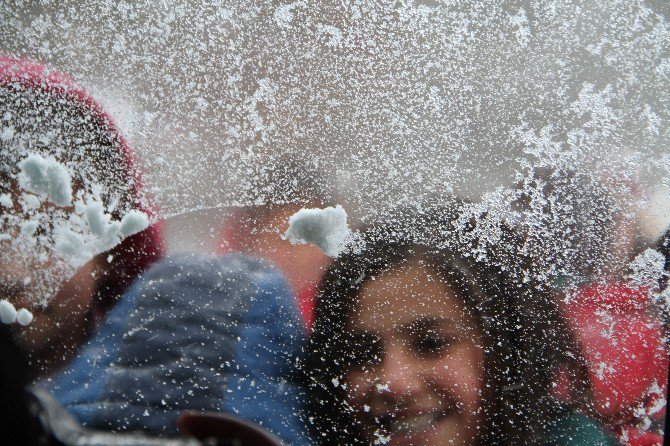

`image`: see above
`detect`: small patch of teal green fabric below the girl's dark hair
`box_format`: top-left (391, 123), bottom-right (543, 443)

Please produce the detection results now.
top-left (545, 412), bottom-right (619, 446)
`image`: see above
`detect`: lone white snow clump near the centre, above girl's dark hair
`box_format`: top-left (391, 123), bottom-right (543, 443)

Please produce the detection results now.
top-left (284, 205), bottom-right (351, 257)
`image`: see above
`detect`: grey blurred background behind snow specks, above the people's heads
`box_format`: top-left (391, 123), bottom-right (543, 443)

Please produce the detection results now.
top-left (0, 0), bottom-right (670, 250)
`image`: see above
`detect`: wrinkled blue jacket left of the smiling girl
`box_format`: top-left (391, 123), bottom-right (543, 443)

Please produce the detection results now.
top-left (46, 254), bottom-right (309, 445)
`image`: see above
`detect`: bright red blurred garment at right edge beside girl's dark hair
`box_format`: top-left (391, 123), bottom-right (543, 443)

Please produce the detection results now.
top-left (563, 284), bottom-right (668, 423)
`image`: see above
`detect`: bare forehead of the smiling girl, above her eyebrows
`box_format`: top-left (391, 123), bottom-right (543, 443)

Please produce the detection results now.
top-left (350, 262), bottom-right (465, 332)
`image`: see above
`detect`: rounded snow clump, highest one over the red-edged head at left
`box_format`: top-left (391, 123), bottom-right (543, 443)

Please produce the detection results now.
top-left (18, 154), bottom-right (72, 206)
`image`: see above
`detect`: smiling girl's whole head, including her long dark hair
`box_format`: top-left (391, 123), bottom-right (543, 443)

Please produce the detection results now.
top-left (308, 212), bottom-right (588, 444)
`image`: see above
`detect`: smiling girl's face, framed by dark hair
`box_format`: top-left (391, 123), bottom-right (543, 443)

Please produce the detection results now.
top-left (344, 261), bottom-right (484, 445)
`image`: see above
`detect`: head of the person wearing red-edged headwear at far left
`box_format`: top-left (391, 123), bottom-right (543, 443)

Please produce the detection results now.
top-left (0, 55), bottom-right (162, 372)
